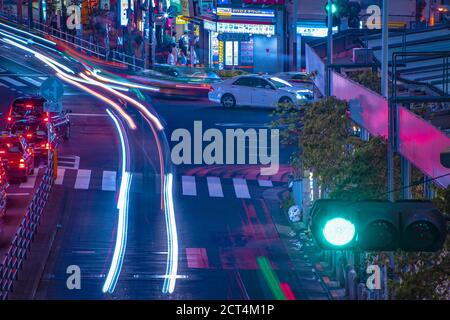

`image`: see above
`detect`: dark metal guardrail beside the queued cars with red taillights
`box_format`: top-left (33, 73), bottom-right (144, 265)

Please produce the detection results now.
top-left (0, 152), bottom-right (55, 300)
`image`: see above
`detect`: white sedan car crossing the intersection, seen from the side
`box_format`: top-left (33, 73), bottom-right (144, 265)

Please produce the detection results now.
top-left (208, 75), bottom-right (313, 108)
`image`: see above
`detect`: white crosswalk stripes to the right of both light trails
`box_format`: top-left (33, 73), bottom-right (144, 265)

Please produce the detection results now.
top-left (181, 176), bottom-right (273, 199)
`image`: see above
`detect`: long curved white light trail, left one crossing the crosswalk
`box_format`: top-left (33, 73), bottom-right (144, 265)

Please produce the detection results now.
top-left (102, 109), bottom-right (132, 293)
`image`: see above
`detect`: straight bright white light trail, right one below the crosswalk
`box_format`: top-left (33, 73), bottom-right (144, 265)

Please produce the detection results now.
top-left (162, 173), bottom-right (178, 293)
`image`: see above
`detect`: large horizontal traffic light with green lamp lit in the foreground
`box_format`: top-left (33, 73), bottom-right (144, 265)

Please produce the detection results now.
top-left (311, 199), bottom-right (447, 252)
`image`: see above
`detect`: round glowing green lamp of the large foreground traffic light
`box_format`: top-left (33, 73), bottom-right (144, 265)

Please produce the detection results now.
top-left (322, 218), bottom-right (356, 247)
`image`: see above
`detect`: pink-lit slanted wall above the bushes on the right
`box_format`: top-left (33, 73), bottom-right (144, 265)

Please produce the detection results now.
top-left (332, 72), bottom-right (450, 188)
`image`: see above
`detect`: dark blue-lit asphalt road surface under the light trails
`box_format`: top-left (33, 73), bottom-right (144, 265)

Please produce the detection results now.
top-left (0, 26), bottom-right (325, 299)
